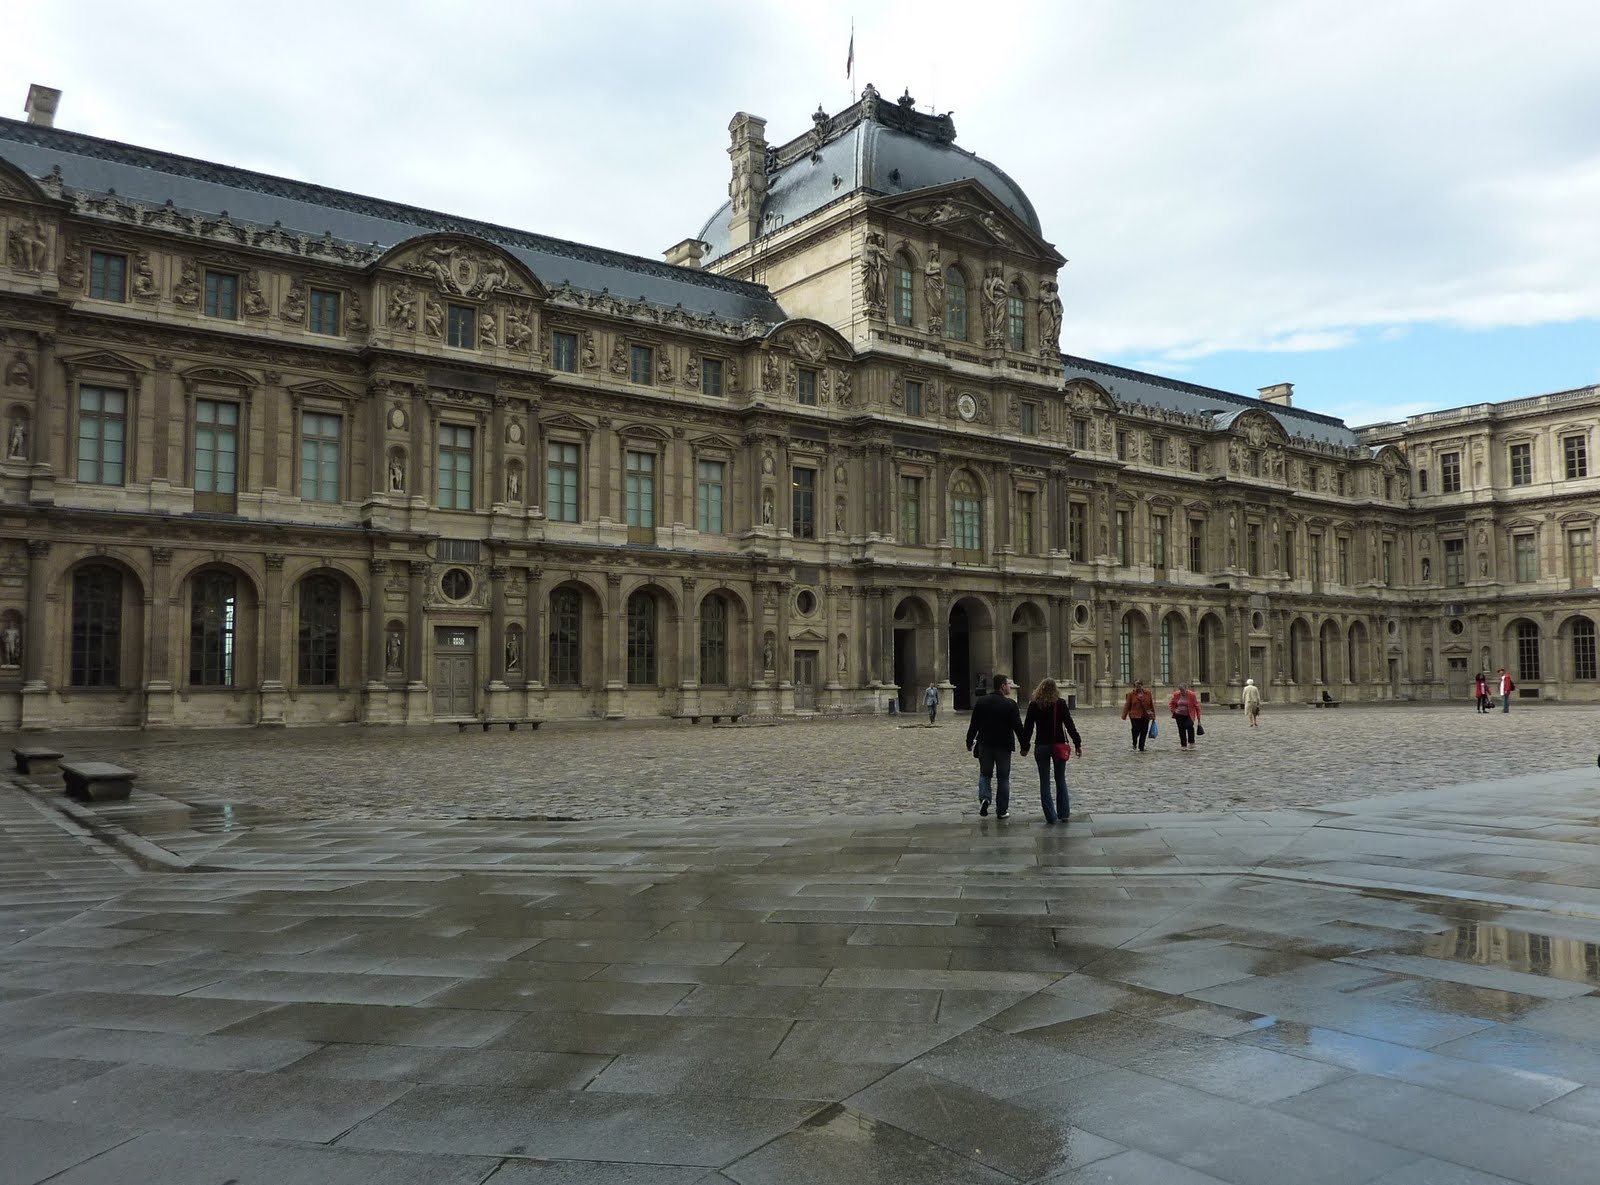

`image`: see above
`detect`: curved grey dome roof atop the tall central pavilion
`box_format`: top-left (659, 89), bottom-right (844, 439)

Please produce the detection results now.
top-left (699, 86), bottom-right (1042, 259)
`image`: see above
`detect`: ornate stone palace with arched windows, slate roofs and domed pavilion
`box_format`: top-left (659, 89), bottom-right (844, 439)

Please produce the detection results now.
top-left (0, 86), bottom-right (1600, 729)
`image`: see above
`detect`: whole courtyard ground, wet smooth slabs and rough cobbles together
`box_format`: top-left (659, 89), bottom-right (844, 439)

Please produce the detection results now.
top-left (0, 707), bottom-right (1600, 1185)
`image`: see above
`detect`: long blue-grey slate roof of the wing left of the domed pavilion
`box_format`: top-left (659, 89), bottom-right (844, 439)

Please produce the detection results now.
top-left (0, 118), bottom-right (786, 323)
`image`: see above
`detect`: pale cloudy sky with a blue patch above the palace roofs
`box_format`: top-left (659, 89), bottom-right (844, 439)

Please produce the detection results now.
top-left (0, 0), bottom-right (1600, 422)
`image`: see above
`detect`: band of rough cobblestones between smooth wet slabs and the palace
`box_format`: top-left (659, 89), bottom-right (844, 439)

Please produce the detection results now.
top-left (21, 704), bottom-right (1600, 819)
